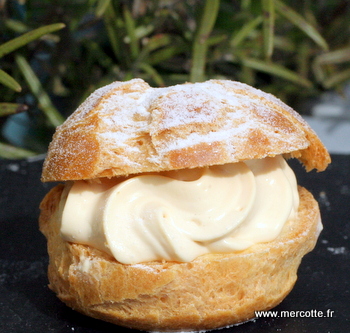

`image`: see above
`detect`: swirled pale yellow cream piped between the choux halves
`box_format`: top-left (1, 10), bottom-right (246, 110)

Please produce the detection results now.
top-left (61, 156), bottom-right (299, 264)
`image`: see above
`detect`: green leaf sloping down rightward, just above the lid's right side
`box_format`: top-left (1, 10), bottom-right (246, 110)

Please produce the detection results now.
top-left (242, 58), bottom-right (312, 88)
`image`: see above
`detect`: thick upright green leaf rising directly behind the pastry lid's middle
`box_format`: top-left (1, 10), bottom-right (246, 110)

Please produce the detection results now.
top-left (190, 0), bottom-right (220, 82)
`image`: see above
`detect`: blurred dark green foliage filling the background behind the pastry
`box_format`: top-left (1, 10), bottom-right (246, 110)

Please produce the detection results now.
top-left (0, 0), bottom-right (350, 158)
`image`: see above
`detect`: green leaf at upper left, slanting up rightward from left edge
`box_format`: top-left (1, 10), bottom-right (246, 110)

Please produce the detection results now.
top-left (0, 23), bottom-right (65, 58)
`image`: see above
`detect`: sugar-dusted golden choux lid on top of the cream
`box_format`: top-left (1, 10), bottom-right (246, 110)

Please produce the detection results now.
top-left (42, 79), bottom-right (330, 181)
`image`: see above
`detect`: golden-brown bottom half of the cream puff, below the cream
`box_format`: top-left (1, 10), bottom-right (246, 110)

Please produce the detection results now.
top-left (40, 185), bottom-right (320, 331)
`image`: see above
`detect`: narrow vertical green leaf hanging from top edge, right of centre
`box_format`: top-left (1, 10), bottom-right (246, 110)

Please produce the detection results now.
top-left (261, 0), bottom-right (275, 58)
